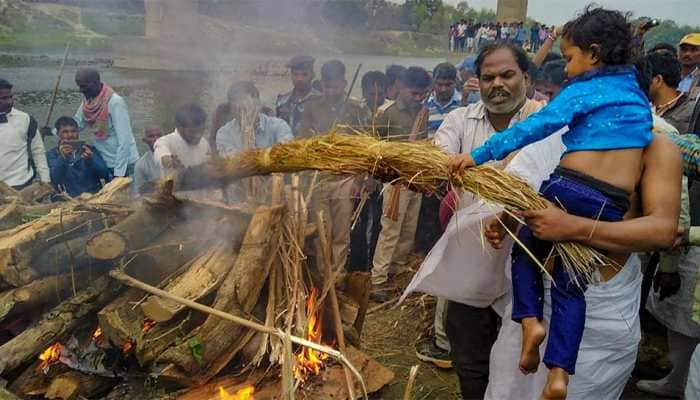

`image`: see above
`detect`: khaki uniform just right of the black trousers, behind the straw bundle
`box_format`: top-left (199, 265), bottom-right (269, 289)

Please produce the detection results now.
top-left (372, 100), bottom-right (427, 285)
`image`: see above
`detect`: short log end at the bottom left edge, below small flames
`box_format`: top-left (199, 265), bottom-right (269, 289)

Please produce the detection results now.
top-left (44, 371), bottom-right (116, 400)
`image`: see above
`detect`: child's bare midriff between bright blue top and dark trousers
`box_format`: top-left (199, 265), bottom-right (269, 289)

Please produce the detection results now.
top-left (559, 149), bottom-right (644, 193)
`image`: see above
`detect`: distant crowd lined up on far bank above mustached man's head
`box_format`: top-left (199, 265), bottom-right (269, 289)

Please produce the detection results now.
top-left (448, 19), bottom-right (555, 53)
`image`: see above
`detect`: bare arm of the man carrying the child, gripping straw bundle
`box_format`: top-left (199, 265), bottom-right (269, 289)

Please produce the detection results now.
top-left (523, 135), bottom-right (682, 253)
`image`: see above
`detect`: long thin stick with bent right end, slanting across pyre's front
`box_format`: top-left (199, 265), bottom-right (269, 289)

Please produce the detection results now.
top-left (109, 270), bottom-right (368, 399)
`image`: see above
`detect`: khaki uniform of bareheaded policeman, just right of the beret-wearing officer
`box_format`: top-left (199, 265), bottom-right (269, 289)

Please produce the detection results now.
top-left (297, 96), bottom-right (370, 271)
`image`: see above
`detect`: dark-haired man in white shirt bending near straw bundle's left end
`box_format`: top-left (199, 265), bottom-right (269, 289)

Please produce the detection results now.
top-left (153, 104), bottom-right (209, 176)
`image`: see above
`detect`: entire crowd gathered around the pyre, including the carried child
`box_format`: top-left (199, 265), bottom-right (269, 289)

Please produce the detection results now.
top-left (0, 4), bottom-right (700, 400)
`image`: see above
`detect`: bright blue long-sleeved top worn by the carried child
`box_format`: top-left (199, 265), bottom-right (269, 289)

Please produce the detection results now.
top-left (471, 66), bottom-right (652, 165)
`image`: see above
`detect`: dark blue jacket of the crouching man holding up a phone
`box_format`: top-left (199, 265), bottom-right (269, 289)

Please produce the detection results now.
top-left (46, 146), bottom-right (112, 197)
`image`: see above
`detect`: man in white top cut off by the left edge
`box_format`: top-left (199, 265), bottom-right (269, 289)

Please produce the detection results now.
top-left (0, 79), bottom-right (51, 190)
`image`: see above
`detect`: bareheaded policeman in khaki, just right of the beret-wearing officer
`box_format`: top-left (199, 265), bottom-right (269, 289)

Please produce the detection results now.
top-left (297, 60), bottom-right (370, 271)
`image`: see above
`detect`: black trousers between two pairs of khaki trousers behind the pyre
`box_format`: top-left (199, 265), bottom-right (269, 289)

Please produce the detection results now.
top-left (347, 190), bottom-right (382, 272)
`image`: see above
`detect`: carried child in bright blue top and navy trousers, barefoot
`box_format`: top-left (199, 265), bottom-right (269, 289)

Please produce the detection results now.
top-left (451, 8), bottom-right (652, 399)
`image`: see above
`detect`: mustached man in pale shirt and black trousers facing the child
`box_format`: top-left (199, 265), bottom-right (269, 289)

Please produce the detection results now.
top-left (435, 43), bottom-right (541, 399)
